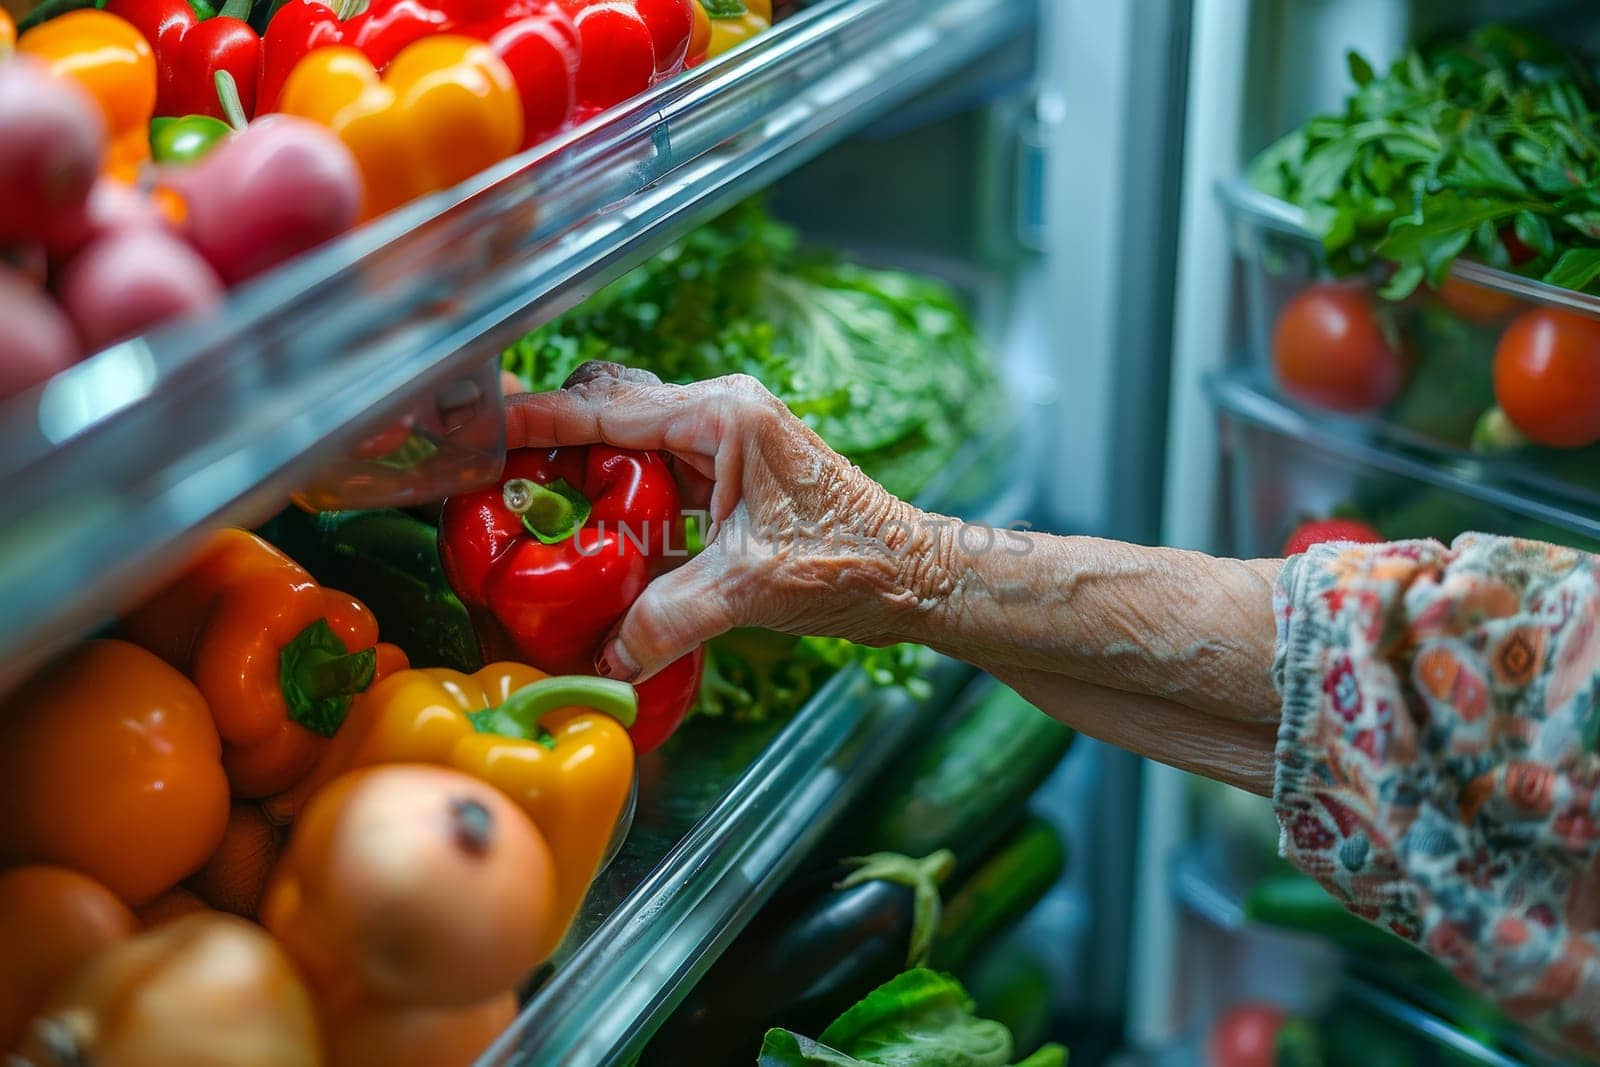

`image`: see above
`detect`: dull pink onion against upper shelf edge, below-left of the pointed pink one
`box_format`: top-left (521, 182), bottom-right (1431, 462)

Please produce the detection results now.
top-left (56, 227), bottom-right (222, 350)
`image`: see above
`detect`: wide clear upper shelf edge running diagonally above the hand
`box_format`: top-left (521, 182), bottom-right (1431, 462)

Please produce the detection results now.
top-left (0, 0), bottom-right (1037, 686)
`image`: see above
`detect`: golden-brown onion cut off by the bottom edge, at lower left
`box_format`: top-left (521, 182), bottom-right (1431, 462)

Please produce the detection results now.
top-left (22, 915), bottom-right (323, 1067)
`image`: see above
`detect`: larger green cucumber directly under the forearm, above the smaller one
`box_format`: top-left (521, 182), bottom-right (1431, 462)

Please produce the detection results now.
top-left (854, 683), bottom-right (1075, 867)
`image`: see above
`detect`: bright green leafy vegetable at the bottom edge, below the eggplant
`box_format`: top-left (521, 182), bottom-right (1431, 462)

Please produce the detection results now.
top-left (760, 969), bottom-right (1067, 1067)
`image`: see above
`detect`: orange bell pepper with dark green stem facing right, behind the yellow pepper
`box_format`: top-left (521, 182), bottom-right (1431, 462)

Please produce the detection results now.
top-left (122, 530), bottom-right (406, 798)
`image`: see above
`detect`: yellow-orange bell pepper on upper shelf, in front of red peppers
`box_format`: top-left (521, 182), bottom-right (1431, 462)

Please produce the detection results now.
top-left (278, 34), bottom-right (523, 219)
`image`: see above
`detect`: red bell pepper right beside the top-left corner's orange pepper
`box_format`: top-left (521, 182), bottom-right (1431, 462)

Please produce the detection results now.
top-left (106, 0), bottom-right (261, 118)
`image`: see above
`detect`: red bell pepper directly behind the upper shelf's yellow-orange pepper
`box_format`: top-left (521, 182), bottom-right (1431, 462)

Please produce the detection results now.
top-left (256, 0), bottom-right (458, 114)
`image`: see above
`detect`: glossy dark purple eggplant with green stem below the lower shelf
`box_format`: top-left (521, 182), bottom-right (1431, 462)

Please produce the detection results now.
top-left (638, 853), bottom-right (954, 1067)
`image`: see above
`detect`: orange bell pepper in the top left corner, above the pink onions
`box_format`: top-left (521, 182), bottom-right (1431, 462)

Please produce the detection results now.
top-left (16, 8), bottom-right (155, 181)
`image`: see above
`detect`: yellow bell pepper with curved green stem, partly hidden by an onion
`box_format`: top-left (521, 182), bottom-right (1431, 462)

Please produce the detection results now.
top-left (290, 662), bottom-right (637, 958)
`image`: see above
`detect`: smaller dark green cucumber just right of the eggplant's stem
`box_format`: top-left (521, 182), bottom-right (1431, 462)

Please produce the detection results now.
top-left (931, 816), bottom-right (1067, 974)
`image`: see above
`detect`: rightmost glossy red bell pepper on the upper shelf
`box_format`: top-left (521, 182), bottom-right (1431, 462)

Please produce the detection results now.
top-left (560, 0), bottom-right (694, 120)
